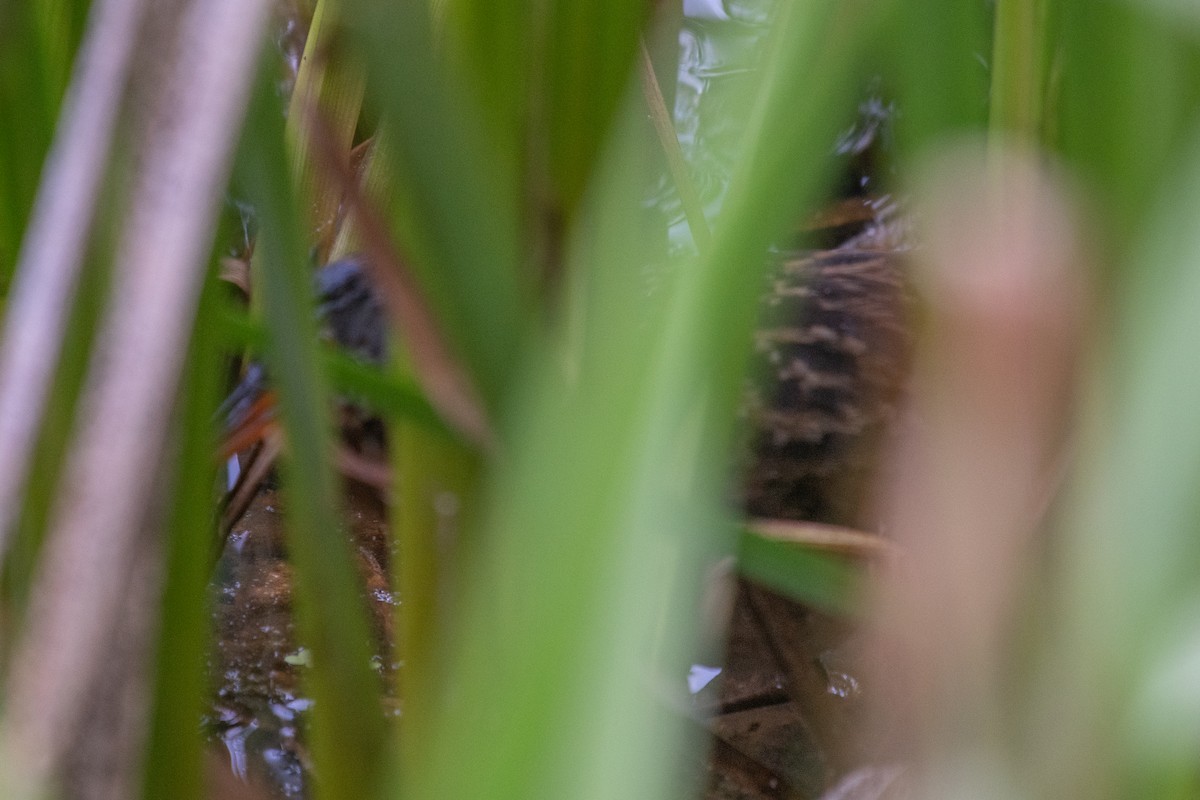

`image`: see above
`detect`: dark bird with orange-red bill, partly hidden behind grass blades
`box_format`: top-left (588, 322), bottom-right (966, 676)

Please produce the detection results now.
top-left (218, 247), bottom-right (912, 527)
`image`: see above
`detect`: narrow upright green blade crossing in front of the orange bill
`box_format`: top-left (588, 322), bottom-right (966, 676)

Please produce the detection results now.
top-left (238, 54), bottom-right (384, 798)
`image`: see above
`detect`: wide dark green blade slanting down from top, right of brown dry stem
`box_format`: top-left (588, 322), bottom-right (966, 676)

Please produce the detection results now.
top-left (343, 0), bottom-right (533, 410)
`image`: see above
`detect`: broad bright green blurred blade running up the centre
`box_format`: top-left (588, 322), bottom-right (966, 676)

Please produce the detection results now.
top-left (407, 5), bottom-right (888, 799)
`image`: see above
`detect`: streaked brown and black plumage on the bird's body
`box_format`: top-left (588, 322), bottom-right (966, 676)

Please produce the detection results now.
top-left (743, 251), bottom-right (911, 524)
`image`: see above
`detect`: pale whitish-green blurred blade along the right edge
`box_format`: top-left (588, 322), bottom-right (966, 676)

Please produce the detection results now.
top-left (1031, 122), bottom-right (1200, 796)
